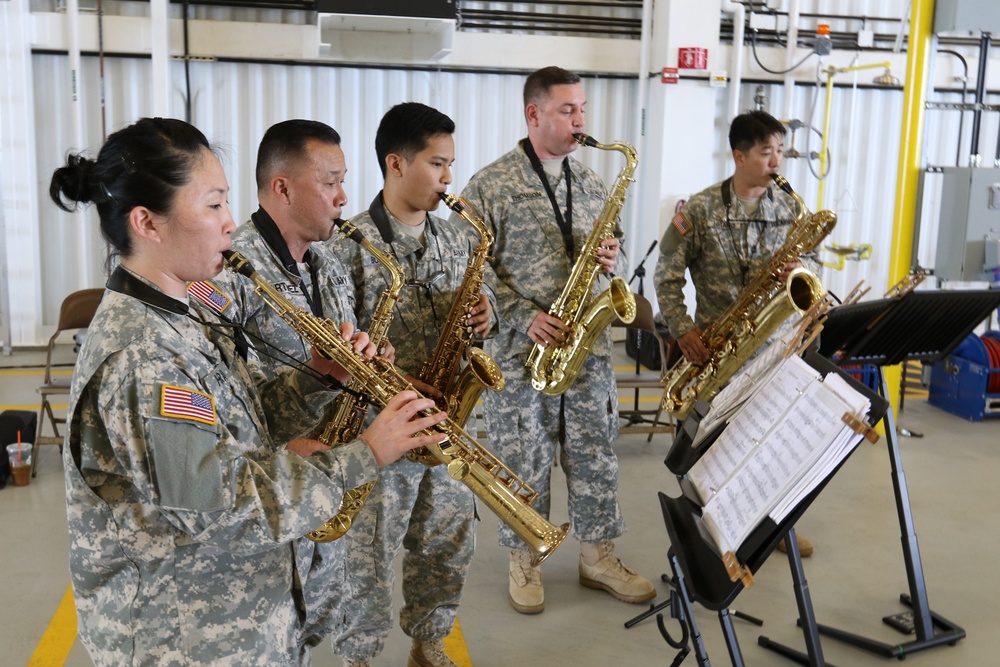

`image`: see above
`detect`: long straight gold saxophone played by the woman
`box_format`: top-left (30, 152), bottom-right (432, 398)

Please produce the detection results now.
top-left (223, 250), bottom-right (569, 565)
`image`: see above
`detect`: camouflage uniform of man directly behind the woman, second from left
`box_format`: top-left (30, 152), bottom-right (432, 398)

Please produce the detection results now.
top-left (201, 208), bottom-right (356, 646)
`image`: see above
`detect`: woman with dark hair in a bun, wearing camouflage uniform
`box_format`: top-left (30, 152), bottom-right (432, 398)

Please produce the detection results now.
top-left (49, 118), bottom-right (446, 666)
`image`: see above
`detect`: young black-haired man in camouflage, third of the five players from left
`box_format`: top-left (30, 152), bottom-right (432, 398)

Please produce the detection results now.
top-left (333, 102), bottom-right (492, 667)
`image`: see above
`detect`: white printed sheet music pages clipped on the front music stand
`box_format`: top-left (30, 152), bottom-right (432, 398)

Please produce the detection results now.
top-left (692, 357), bottom-right (868, 553)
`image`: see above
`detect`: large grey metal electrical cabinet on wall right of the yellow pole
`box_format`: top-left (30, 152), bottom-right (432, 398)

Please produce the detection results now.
top-left (934, 167), bottom-right (1000, 280)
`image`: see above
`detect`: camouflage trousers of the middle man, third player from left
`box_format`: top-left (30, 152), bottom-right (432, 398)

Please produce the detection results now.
top-left (333, 459), bottom-right (475, 661)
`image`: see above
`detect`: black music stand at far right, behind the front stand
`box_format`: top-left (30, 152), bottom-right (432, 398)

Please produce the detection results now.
top-left (819, 290), bottom-right (1000, 659)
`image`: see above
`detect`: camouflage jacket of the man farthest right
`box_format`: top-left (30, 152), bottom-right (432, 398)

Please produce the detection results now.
top-left (653, 180), bottom-right (819, 338)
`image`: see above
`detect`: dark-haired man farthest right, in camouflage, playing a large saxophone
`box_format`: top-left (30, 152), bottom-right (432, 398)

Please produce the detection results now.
top-left (653, 111), bottom-right (819, 556)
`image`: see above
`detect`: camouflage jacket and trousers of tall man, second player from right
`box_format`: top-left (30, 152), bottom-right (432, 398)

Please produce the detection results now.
top-left (462, 140), bottom-right (627, 549)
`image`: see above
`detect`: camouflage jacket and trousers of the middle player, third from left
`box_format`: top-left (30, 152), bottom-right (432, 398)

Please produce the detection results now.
top-left (324, 193), bottom-right (494, 661)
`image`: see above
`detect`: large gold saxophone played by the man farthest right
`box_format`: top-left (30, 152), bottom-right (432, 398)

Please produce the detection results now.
top-left (662, 174), bottom-right (837, 419)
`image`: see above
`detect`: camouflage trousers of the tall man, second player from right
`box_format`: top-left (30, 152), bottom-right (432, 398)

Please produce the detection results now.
top-left (483, 356), bottom-right (625, 549)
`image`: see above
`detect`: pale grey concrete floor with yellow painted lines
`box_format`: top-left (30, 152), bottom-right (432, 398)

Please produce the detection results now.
top-left (0, 344), bottom-right (1000, 667)
